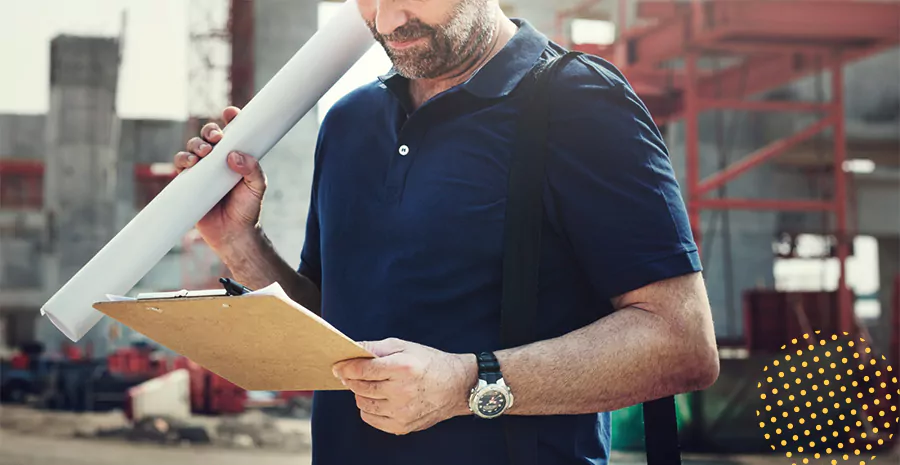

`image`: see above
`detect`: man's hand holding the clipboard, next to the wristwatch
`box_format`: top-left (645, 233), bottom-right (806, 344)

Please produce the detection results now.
top-left (334, 339), bottom-right (478, 435)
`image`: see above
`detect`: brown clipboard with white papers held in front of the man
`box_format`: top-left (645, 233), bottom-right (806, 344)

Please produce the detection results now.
top-left (94, 283), bottom-right (375, 391)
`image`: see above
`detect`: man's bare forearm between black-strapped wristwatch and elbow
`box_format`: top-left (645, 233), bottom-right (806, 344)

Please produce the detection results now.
top-left (497, 307), bottom-right (717, 415)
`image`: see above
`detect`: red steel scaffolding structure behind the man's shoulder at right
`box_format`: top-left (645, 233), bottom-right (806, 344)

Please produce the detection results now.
top-left (557, 0), bottom-right (900, 332)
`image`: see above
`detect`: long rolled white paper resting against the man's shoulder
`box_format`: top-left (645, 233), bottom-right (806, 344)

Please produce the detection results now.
top-left (41, 0), bottom-right (375, 342)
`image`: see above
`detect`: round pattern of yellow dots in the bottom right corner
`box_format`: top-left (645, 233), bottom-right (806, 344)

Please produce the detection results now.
top-left (756, 331), bottom-right (900, 465)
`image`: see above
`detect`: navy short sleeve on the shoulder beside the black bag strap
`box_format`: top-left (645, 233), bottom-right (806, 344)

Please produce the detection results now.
top-left (546, 56), bottom-right (701, 299)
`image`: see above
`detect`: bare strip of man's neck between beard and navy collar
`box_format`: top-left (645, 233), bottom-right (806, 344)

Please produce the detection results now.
top-left (409, 11), bottom-right (516, 108)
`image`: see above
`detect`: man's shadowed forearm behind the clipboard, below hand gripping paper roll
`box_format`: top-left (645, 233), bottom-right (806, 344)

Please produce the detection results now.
top-left (219, 229), bottom-right (321, 314)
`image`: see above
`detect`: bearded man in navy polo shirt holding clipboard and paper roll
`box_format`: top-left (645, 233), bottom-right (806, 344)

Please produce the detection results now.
top-left (175, 0), bottom-right (718, 465)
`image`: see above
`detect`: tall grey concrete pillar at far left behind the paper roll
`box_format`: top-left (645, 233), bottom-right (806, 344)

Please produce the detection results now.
top-left (38, 36), bottom-right (120, 356)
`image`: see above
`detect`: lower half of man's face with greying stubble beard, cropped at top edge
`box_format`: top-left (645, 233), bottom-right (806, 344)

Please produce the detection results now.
top-left (359, 0), bottom-right (494, 79)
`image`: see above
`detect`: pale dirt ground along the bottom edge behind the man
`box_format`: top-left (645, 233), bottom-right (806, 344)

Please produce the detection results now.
top-left (0, 406), bottom-right (900, 465)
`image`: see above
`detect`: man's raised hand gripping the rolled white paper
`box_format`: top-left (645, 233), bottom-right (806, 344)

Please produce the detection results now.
top-left (175, 107), bottom-right (266, 252)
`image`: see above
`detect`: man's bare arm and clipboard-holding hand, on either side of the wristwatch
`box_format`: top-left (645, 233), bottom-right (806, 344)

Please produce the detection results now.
top-left (335, 273), bottom-right (719, 434)
